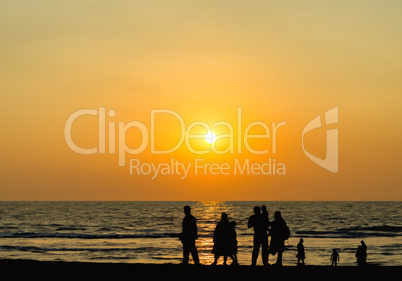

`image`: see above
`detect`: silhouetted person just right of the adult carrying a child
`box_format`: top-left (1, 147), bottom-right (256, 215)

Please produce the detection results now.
top-left (269, 211), bottom-right (289, 266)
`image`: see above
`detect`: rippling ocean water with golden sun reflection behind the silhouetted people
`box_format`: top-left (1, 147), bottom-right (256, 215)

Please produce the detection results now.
top-left (0, 201), bottom-right (402, 266)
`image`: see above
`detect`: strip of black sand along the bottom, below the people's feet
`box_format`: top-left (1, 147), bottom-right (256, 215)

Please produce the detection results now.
top-left (0, 260), bottom-right (402, 280)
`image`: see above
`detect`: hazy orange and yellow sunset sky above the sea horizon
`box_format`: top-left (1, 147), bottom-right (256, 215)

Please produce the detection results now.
top-left (0, 0), bottom-right (402, 201)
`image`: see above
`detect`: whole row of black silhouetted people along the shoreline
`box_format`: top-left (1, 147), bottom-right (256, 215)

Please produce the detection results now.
top-left (180, 206), bottom-right (367, 266)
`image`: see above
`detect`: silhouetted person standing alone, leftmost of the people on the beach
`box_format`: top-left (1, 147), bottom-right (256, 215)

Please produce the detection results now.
top-left (180, 206), bottom-right (200, 264)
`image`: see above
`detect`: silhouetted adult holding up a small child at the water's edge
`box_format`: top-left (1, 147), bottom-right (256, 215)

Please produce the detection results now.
top-left (248, 206), bottom-right (268, 265)
